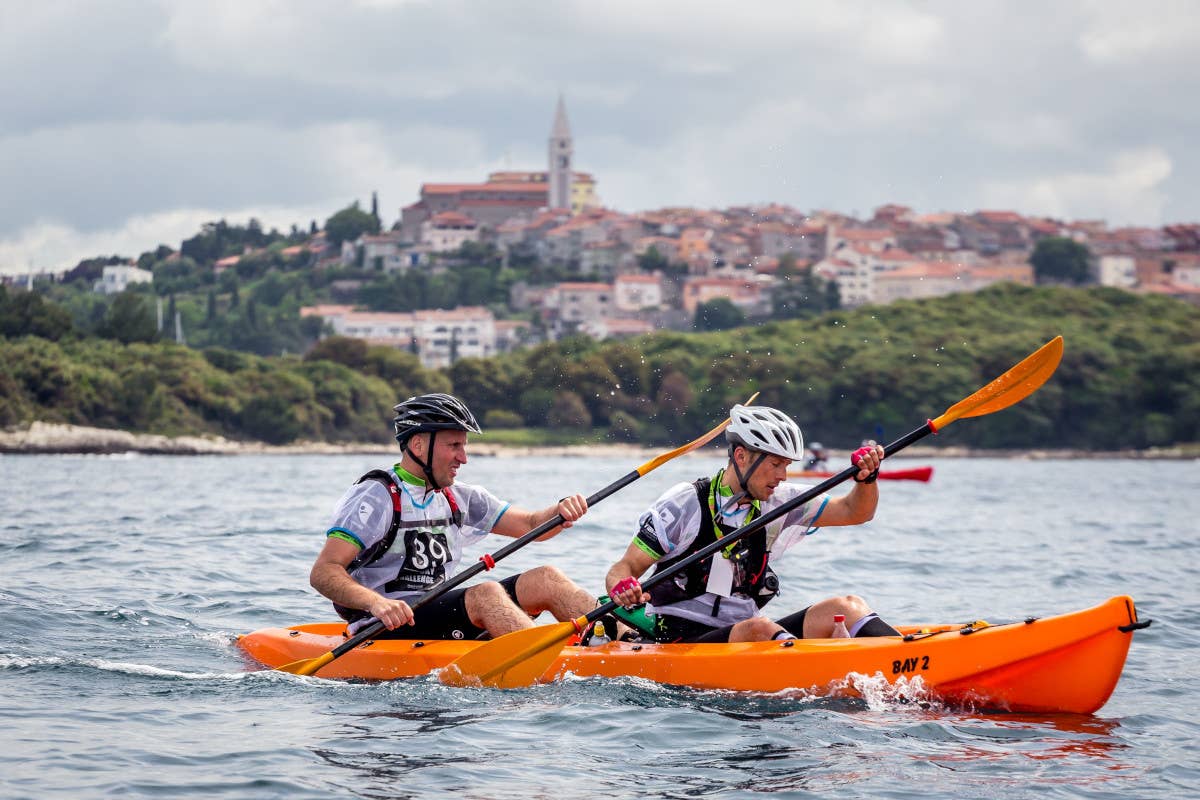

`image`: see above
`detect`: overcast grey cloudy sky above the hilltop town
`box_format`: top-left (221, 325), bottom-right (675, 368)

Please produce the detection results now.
top-left (0, 0), bottom-right (1200, 272)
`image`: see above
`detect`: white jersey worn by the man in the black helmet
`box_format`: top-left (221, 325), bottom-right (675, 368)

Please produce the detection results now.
top-left (325, 470), bottom-right (510, 631)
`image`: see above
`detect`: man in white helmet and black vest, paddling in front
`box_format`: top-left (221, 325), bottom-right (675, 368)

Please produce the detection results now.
top-left (605, 405), bottom-right (898, 642)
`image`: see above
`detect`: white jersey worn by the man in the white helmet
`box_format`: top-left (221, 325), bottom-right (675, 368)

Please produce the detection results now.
top-left (634, 482), bottom-right (829, 627)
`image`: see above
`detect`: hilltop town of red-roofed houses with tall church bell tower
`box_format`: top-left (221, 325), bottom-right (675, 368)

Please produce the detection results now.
top-left (10, 100), bottom-right (1200, 367)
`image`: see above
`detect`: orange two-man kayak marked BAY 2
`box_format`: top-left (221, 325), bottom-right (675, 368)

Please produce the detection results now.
top-left (238, 596), bottom-right (1150, 714)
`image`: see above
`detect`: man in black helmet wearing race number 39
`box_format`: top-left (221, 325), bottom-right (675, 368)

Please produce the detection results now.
top-left (308, 393), bottom-right (595, 639)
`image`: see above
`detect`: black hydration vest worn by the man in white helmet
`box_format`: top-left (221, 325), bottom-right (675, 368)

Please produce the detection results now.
top-left (650, 477), bottom-right (779, 616)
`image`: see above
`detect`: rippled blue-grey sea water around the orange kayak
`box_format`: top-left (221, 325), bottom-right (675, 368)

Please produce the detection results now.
top-left (0, 455), bottom-right (1200, 800)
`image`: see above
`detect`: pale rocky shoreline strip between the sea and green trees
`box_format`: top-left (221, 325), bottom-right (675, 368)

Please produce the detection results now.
top-left (0, 422), bottom-right (1200, 461)
